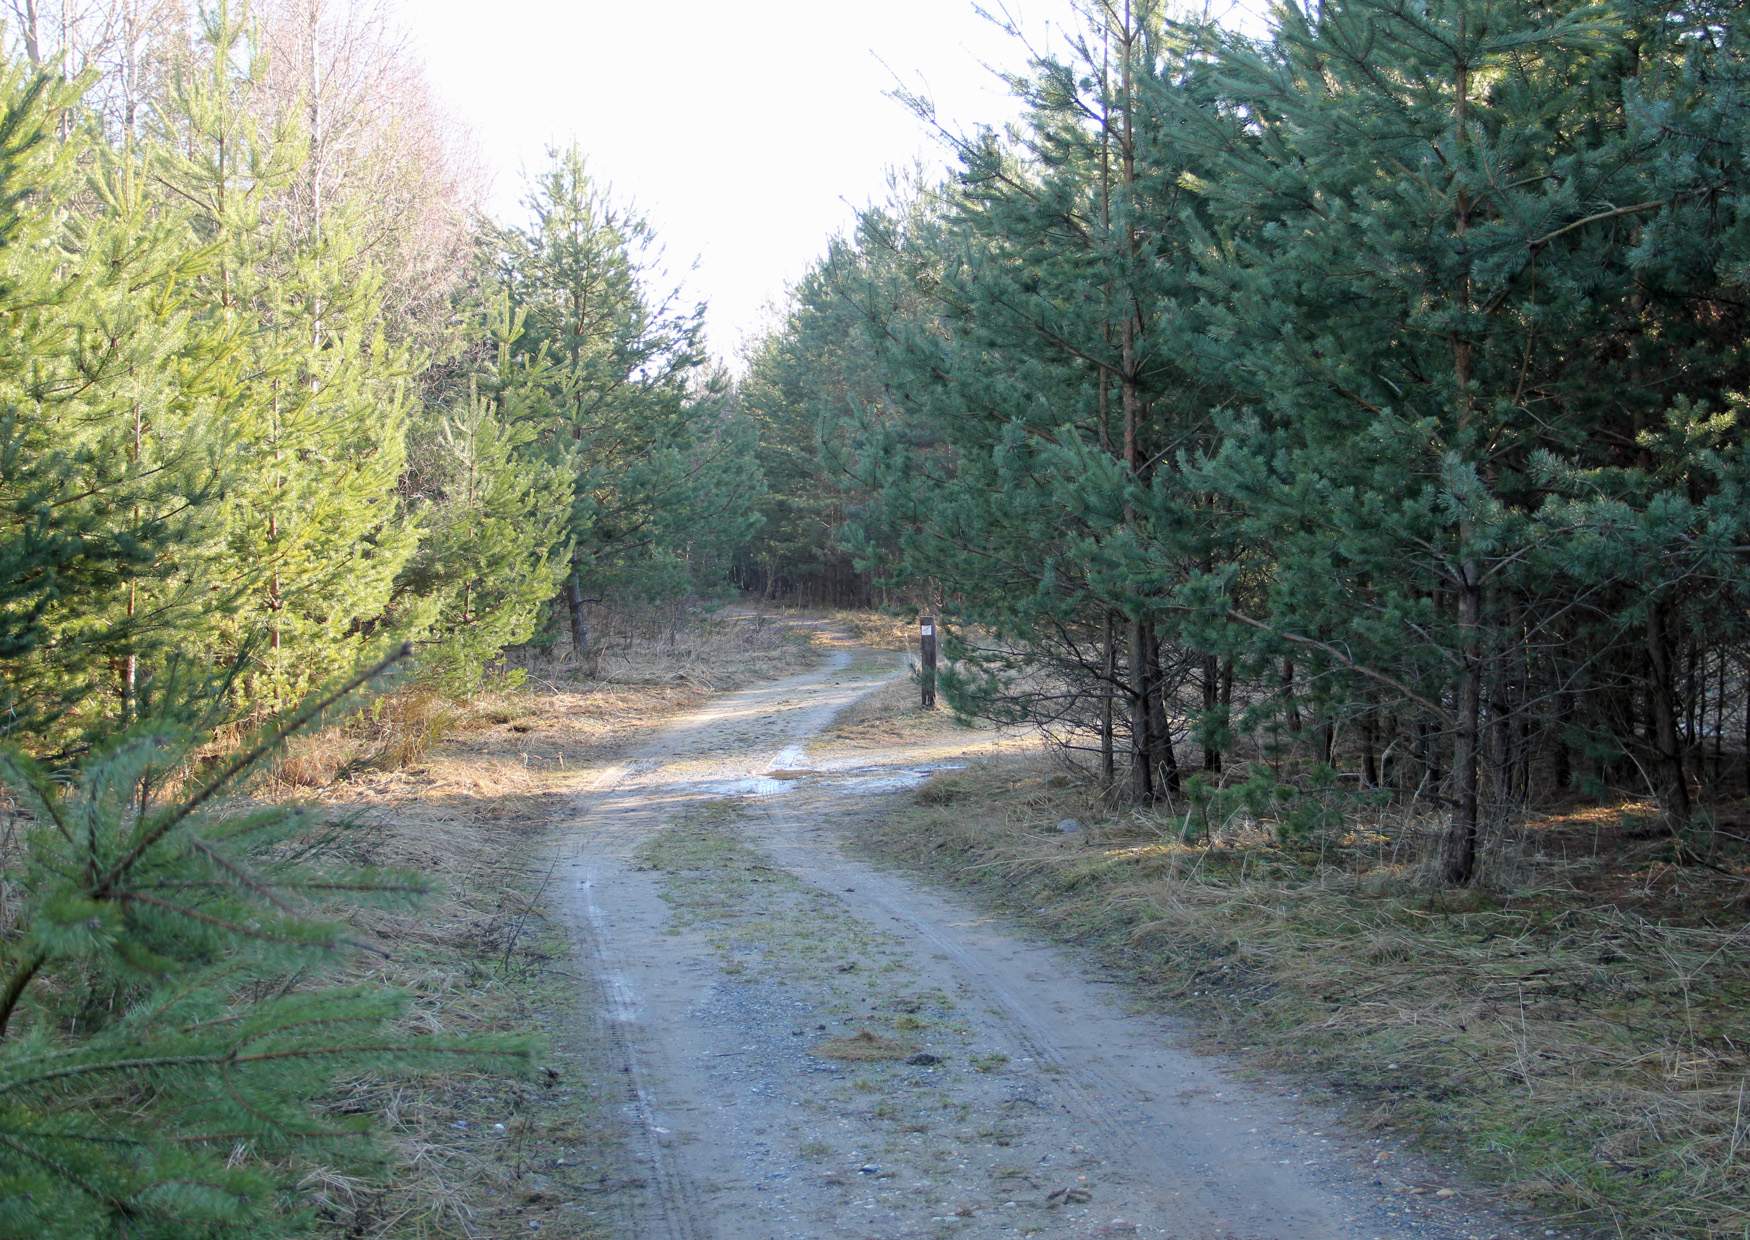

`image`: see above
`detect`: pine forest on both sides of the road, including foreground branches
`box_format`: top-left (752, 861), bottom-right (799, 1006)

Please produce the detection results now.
top-left (0, 0), bottom-right (1750, 1237)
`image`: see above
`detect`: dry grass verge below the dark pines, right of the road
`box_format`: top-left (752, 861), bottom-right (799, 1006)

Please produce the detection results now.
top-left (880, 759), bottom-right (1750, 1238)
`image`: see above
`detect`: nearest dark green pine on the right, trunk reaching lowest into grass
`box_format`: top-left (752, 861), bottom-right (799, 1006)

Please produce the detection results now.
top-left (1181, 0), bottom-right (1750, 881)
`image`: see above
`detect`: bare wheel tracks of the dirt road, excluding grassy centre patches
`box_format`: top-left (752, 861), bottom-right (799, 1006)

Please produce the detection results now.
top-left (560, 640), bottom-right (1519, 1240)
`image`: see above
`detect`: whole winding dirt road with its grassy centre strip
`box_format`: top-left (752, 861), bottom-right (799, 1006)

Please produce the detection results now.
top-left (553, 633), bottom-right (1542, 1240)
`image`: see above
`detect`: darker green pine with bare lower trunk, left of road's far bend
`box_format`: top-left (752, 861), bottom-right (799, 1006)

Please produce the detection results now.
top-left (502, 149), bottom-right (756, 661)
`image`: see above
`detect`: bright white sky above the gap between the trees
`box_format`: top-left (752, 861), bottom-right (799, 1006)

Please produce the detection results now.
top-left (411, 0), bottom-right (1260, 362)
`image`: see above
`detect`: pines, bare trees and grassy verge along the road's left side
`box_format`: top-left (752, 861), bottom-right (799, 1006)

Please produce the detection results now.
top-left (0, 0), bottom-right (782, 1238)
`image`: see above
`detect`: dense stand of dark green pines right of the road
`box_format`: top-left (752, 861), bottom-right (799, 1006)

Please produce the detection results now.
top-left (742, 0), bottom-right (1750, 881)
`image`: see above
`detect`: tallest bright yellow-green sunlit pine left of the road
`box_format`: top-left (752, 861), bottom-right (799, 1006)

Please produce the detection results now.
top-left (159, 5), bottom-right (427, 712)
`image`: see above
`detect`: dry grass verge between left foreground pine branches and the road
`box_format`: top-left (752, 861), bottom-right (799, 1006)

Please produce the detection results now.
top-left (285, 694), bottom-right (614, 1237)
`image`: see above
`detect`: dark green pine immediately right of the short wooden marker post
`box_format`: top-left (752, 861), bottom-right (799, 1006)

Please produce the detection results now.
top-left (822, 3), bottom-right (1230, 801)
